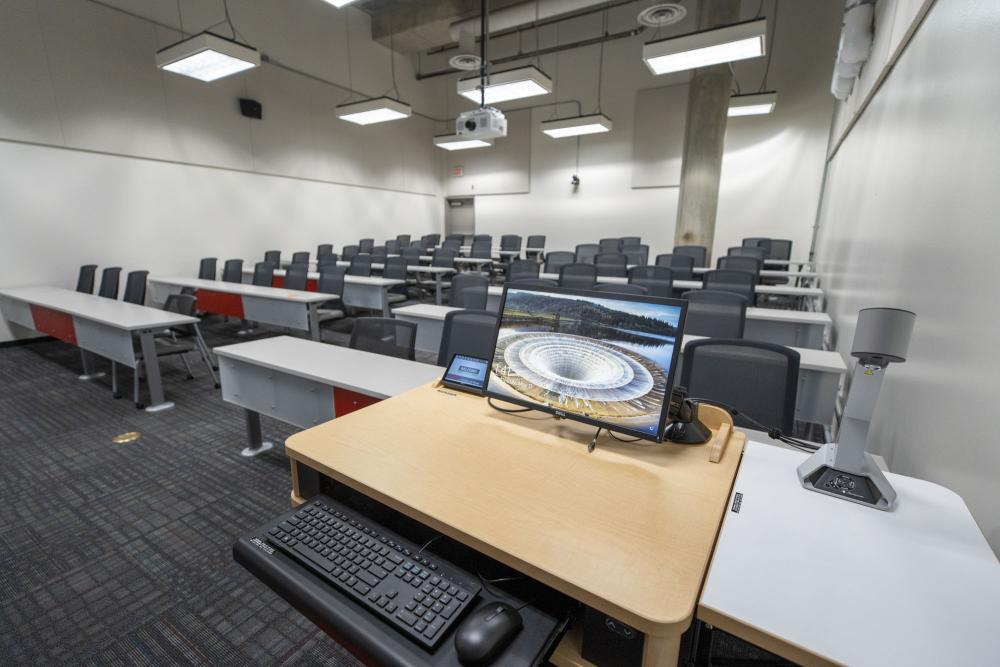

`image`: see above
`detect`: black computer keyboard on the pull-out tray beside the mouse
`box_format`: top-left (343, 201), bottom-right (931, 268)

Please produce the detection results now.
top-left (267, 496), bottom-right (482, 649)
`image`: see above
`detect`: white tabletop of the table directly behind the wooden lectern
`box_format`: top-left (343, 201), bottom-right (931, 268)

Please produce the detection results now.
top-left (214, 336), bottom-right (444, 398)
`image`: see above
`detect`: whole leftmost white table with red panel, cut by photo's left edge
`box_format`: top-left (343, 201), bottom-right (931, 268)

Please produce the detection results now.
top-left (0, 287), bottom-right (198, 412)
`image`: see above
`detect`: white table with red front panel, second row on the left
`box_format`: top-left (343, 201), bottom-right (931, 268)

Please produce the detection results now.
top-left (149, 276), bottom-right (340, 340)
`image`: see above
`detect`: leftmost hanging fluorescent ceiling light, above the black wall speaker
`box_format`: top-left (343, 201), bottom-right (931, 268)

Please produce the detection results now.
top-left (156, 32), bottom-right (260, 81)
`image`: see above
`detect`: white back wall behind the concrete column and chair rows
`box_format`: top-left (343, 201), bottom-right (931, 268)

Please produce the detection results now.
top-left (423, 0), bottom-right (842, 257)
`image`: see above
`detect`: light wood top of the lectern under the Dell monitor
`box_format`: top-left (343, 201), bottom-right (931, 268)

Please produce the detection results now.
top-left (286, 385), bottom-right (743, 648)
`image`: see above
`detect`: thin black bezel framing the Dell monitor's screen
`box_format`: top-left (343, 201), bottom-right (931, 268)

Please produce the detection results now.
top-left (483, 285), bottom-right (687, 442)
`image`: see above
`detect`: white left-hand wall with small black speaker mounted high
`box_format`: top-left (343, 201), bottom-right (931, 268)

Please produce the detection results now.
top-left (0, 0), bottom-right (443, 340)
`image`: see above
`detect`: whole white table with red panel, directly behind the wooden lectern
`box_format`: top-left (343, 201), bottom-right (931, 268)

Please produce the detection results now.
top-left (215, 336), bottom-right (444, 456)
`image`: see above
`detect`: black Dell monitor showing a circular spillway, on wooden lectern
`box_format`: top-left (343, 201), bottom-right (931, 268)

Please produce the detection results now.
top-left (486, 287), bottom-right (687, 441)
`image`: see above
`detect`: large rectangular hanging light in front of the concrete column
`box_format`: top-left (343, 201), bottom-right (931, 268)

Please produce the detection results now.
top-left (642, 18), bottom-right (767, 74)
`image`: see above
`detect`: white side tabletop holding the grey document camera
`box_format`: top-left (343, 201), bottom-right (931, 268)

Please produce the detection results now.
top-left (698, 442), bottom-right (1000, 667)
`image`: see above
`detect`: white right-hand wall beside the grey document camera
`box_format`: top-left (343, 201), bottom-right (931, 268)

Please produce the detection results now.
top-left (818, 0), bottom-right (1000, 552)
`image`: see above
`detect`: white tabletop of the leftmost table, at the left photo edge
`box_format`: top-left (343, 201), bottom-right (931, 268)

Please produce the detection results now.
top-left (0, 286), bottom-right (198, 331)
